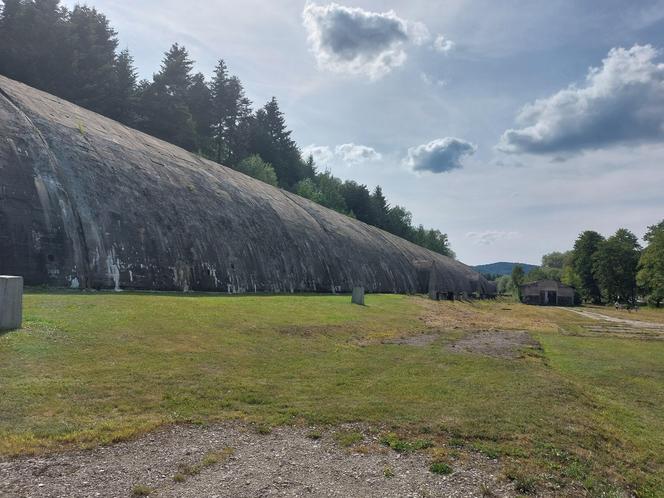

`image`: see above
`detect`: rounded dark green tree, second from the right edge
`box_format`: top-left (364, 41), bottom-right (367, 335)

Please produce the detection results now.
top-left (593, 228), bottom-right (641, 302)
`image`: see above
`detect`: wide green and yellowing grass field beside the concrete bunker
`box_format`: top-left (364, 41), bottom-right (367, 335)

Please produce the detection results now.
top-left (0, 293), bottom-right (664, 496)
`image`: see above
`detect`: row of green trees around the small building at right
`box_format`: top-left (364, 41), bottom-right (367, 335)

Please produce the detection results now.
top-left (497, 220), bottom-right (664, 307)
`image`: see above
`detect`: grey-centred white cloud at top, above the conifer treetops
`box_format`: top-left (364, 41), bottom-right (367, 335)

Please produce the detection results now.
top-left (302, 3), bottom-right (430, 79)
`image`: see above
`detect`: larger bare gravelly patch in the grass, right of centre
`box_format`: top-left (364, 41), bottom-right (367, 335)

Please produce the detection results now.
top-left (449, 330), bottom-right (540, 359)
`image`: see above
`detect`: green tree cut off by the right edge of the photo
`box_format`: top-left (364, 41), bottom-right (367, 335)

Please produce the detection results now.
top-left (636, 221), bottom-right (664, 307)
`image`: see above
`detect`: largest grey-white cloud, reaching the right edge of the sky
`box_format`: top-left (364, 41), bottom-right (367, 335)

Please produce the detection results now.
top-left (497, 45), bottom-right (664, 157)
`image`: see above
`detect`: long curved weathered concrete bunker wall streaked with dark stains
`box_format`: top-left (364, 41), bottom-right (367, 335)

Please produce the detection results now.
top-left (0, 77), bottom-right (486, 293)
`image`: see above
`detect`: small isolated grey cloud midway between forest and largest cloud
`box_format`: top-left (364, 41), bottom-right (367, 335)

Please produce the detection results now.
top-left (404, 137), bottom-right (477, 173)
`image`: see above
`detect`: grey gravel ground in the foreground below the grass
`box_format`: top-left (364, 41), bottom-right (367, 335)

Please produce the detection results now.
top-left (0, 424), bottom-right (515, 498)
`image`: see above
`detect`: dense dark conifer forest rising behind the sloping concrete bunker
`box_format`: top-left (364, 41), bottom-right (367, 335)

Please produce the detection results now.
top-left (0, 0), bottom-right (454, 257)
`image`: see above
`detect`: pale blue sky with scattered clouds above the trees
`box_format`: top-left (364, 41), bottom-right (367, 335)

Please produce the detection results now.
top-left (64, 0), bottom-right (664, 264)
